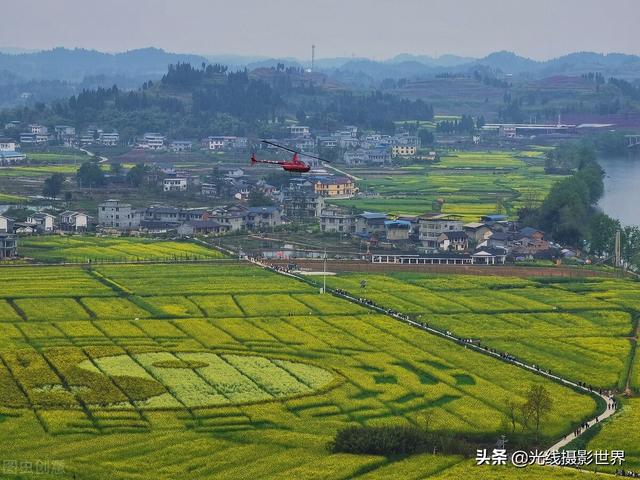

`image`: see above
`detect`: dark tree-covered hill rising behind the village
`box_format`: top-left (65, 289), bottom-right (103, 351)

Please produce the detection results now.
top-left (0, 63), bottom-right (433, 139)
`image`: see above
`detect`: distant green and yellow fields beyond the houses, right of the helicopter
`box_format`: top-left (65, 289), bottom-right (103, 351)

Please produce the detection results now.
top-left (332, 151), bottom-right (562, 221)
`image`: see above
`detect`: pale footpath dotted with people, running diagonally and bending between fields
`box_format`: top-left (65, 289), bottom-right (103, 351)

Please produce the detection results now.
top-left (249, 259), bottom-right (617, 462)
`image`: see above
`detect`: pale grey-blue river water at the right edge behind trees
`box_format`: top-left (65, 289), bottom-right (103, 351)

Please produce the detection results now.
top-left (598, 154), bottom-right (640, 226)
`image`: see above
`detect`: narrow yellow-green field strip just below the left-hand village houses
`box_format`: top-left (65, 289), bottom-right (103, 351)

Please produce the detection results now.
top-left (20, 235), bottom-right (223, 263)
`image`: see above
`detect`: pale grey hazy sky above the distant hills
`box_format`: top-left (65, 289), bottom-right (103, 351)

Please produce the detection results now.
top-left (0, 0), bottom-right (640, 59)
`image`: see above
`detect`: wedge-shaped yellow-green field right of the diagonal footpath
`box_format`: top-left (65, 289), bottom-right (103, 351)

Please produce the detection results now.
top-left (328, 273), bottom-right (640, 387)
